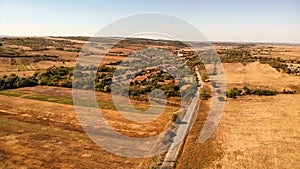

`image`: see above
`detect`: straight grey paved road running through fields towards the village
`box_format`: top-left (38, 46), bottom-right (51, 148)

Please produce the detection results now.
top-left (161, 67), bottom-right (203, 169)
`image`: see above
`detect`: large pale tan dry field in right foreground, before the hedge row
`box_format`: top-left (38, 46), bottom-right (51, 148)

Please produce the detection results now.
top-left (215, 94), bottom-right (300, 168)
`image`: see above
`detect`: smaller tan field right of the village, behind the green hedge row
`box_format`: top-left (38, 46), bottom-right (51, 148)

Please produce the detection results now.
top-left (223, 62), bottom-right (300, 93)
